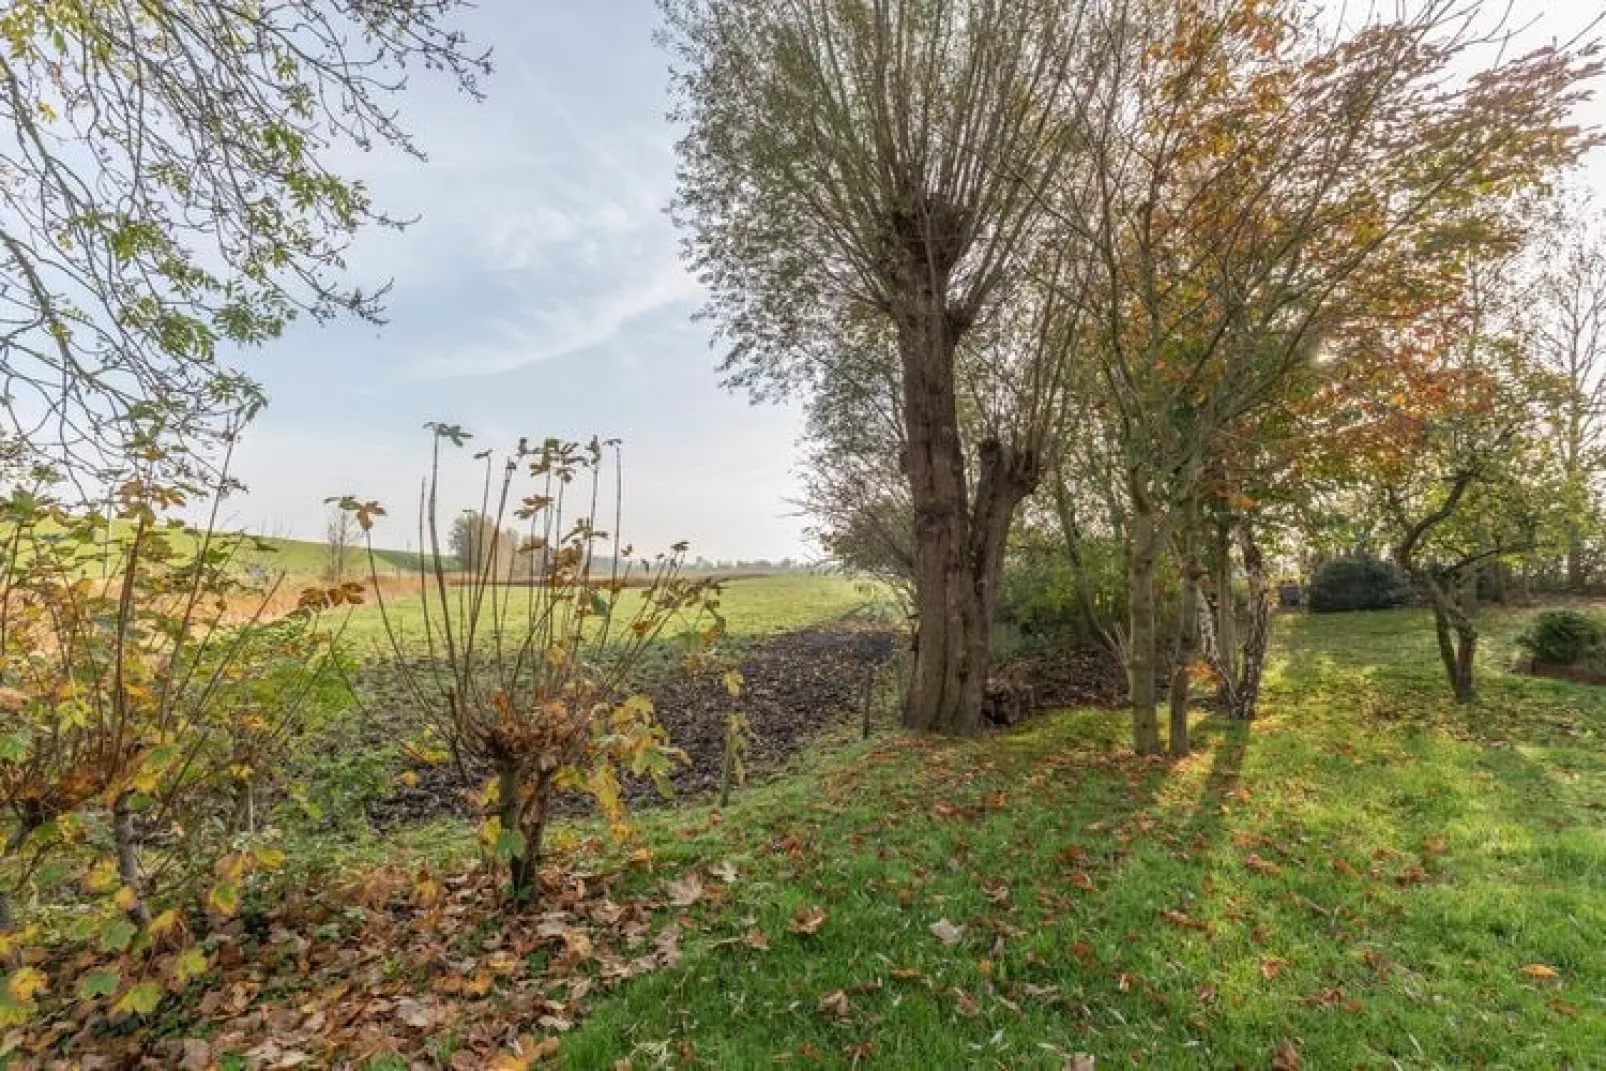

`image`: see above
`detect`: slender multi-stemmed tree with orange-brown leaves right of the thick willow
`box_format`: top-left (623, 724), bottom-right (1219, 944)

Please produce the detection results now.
top-left (1066, 0), bottom-right (1600, 753)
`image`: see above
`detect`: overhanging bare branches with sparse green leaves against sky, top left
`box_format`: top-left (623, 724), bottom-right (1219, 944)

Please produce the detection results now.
top-left (0, 0), bottom-right (488, 475)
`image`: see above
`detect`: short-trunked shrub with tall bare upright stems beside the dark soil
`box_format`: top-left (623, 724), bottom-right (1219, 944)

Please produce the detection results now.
top-left (353, 424), bottom-right (723, 902)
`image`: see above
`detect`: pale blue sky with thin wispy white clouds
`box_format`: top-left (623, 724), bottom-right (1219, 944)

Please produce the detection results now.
top-left (216, 0), bottom-right (1606, 559)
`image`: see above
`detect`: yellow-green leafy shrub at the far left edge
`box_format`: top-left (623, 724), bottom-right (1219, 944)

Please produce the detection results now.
top-left (0, 474), bottom-right (360, 1026)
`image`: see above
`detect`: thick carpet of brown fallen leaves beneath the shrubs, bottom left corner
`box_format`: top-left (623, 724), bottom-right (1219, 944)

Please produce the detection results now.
top-left (6, 867), bottom-right (695, 1068)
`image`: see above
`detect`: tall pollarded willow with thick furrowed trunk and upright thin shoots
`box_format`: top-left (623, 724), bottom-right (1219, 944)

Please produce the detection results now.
top-left (665, 0), bottom-right (1102, 734)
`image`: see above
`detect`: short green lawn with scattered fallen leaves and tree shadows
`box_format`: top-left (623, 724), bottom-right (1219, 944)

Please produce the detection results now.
top-left (560, 612), bottom-right (1606, 1068)
